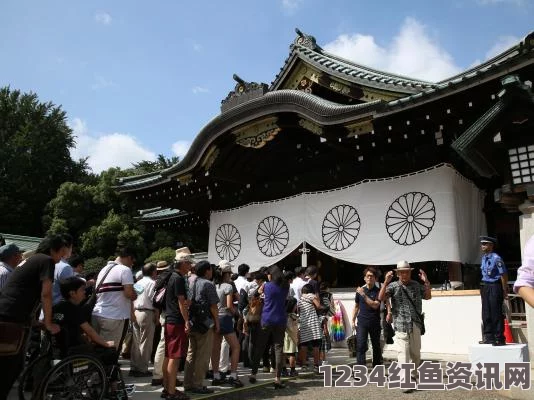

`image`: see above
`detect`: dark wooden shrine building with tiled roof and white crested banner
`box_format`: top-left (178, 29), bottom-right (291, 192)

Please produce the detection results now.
top-left (117, 29), bottom-right (534, 354)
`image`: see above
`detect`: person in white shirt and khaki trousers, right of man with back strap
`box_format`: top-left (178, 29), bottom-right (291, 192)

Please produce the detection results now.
top-left (130, 263), bottom-right (157, 377)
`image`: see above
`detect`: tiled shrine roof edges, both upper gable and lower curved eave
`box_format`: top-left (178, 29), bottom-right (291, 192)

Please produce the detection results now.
top-left (117, 31), bottom-right (534, 192)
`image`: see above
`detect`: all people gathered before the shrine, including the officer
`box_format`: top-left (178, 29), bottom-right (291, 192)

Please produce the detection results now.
top-left (0, 235), bottom-right (534, 400)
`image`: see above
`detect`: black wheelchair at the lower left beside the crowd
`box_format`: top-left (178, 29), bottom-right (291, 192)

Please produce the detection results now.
top-left (18, 334), bottom-right (135, 400)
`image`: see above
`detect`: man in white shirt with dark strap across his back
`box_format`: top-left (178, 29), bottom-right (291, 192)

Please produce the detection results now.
top-left (91, 248), bottom-right (137, 348)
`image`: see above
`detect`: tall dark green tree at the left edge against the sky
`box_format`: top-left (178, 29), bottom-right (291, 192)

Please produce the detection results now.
top-left (0, 87), bottom-right (87, 235)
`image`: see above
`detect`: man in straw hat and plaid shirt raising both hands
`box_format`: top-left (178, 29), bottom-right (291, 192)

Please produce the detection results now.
top-left (378, 261), bottom-right (432, 393)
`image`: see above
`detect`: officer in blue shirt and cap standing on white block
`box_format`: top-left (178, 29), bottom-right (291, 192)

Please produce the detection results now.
top-left (479, 236), bottom-right (508, 346)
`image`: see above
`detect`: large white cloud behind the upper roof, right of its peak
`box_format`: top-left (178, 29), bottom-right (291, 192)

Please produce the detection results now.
top-left (324, 18), bottom-right (460, 81)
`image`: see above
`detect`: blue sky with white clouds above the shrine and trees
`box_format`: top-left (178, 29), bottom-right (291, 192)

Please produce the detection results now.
top-left (0, 0), bottom-right (534, 172)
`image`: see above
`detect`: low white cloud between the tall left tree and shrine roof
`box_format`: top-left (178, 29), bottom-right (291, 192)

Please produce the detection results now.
top-left (69, 118), bottom-right (156, 173)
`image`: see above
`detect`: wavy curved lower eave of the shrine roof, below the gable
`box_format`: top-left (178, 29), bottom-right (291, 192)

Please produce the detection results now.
top-left (115, 89), bottom-right (386, 192)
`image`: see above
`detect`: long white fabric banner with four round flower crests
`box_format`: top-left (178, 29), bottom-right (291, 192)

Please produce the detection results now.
top-left (208, 165), bottom-right (485, 271)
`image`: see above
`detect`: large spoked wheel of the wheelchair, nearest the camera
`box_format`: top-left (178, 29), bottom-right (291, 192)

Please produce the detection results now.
top-left (39, 355), bottom-right (108, 400)
